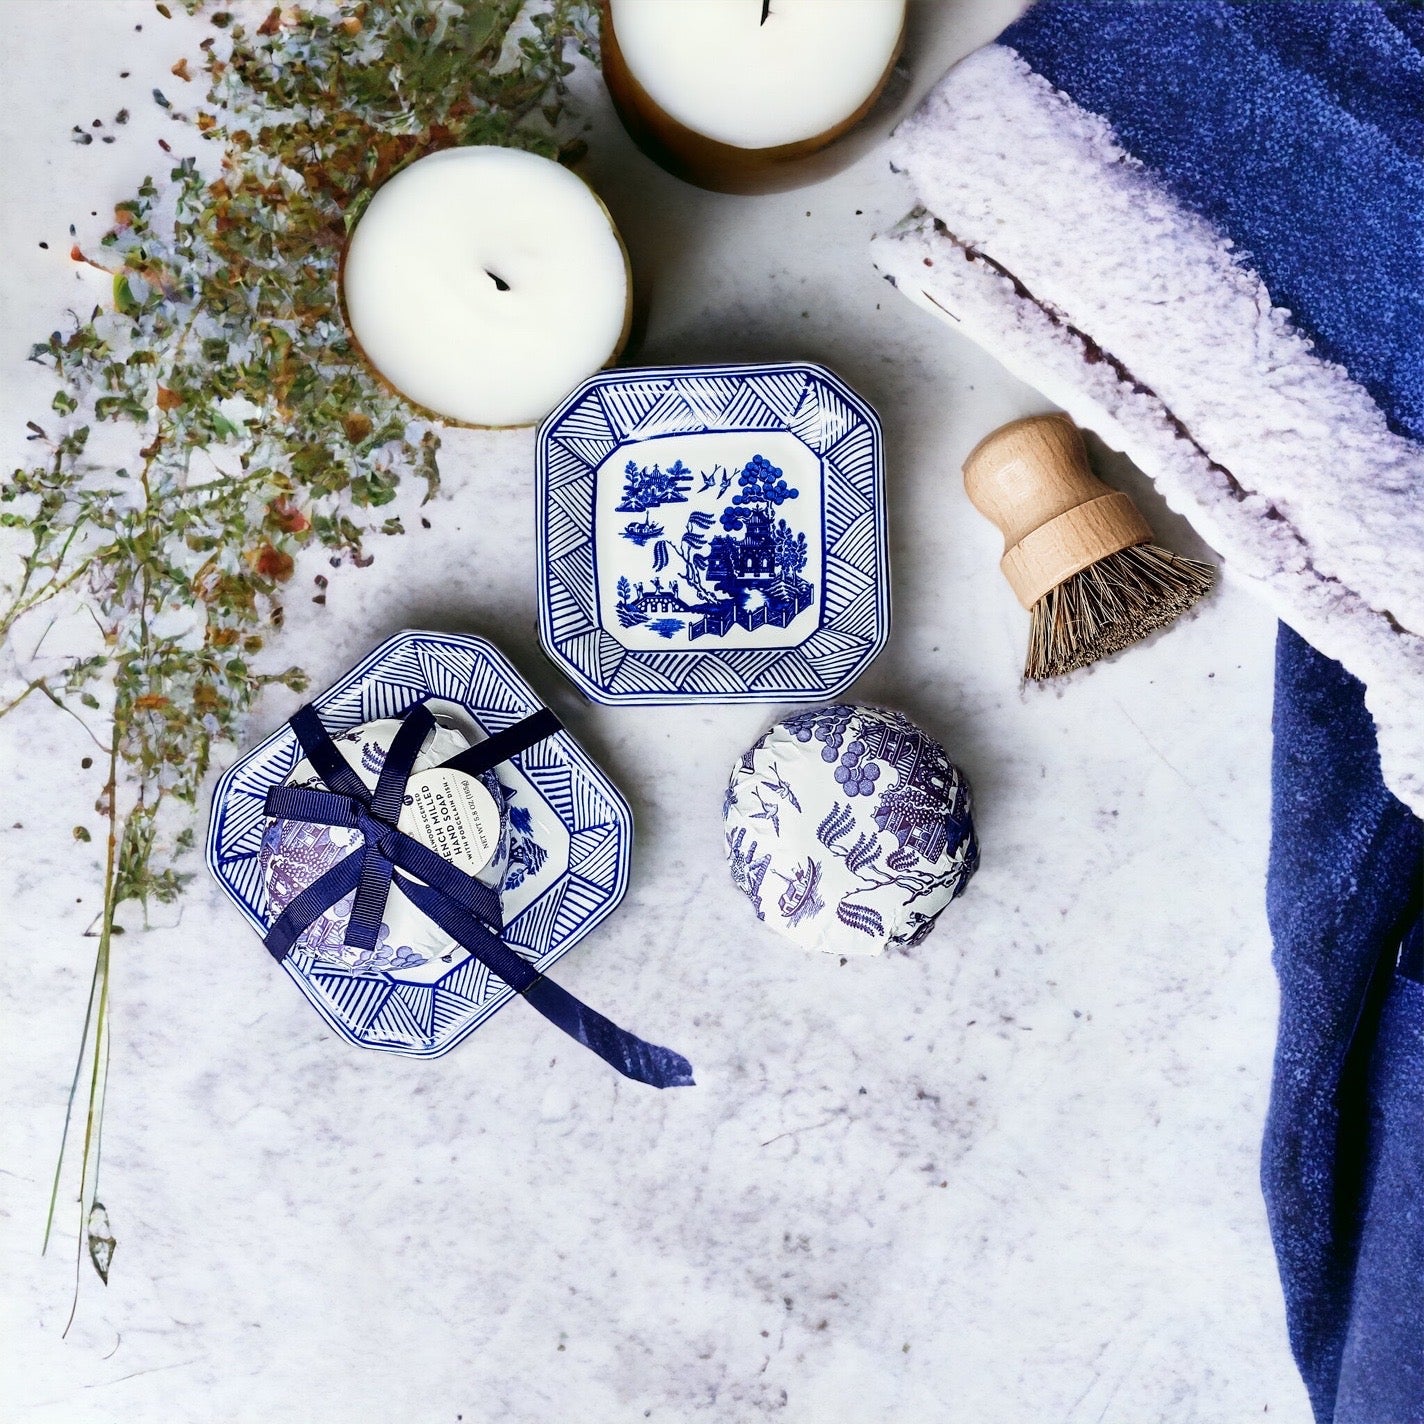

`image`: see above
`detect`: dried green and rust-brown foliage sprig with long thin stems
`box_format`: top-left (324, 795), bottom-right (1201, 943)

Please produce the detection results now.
top-left (0, 0), bottom-right (592, 1310)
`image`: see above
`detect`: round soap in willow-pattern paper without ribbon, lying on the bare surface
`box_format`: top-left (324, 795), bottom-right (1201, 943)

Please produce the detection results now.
top-left (723, 703), bottom-right (978, 954)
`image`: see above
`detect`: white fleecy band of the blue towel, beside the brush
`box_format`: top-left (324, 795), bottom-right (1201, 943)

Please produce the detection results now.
top-left (871, 46), bottom-right (1424, 813)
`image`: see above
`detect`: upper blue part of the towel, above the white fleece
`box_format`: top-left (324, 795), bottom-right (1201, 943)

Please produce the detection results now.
top-left (1000, 0), bottom-right (1424, 438)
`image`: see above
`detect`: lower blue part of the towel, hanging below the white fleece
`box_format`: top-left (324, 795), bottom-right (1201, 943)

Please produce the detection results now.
top-left (1262, 625), bottom-right (1424, 1424)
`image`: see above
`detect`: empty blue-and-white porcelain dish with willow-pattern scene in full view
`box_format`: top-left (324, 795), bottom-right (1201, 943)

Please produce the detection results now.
top-left (537, 362), bottom-right (890, 703)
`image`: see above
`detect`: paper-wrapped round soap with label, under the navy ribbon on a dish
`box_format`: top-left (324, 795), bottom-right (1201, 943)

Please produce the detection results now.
top-left (259, 718), bottom-right (510, 971)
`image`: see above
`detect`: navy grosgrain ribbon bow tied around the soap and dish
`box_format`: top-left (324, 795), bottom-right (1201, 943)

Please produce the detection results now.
top-left (265, 702), bottom-right (693, 1088)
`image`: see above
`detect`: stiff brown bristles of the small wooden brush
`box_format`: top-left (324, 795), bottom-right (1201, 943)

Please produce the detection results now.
top-left (1024, 544), bottom-right (1216, 679)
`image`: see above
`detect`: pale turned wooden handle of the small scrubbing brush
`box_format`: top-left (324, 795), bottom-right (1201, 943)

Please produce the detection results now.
top-left (964, 414), bottom-right (1152, 608)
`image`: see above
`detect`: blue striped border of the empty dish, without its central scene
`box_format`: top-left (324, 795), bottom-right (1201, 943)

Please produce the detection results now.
top-left (535, 362), bottom-right (890, 703)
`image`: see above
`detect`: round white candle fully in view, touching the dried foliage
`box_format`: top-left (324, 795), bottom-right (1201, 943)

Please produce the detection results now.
top-left (342, 147), bottom-right (631, 426)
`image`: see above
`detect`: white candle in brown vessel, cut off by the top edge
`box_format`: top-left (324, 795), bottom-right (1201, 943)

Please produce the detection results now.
top-left (602, 0), bottom-right (906, 192)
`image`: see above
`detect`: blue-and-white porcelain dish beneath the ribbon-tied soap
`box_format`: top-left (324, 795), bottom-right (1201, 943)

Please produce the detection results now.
top-left (206, 632), bottom-right (632, 1058)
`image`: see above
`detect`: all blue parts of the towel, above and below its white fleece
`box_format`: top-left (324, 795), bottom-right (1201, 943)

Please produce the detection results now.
top-left (1000, 8), bottom-right (1424, 1424)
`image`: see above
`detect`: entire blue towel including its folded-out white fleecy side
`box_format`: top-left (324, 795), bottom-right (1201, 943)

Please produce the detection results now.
top-left (877, 0), bottom-right (1424, 1424)
